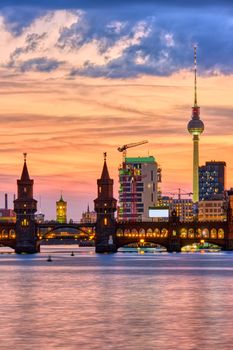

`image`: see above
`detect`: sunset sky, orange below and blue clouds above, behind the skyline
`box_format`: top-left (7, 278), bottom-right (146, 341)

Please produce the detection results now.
top-left (0, 0), bottom-right (233, 221)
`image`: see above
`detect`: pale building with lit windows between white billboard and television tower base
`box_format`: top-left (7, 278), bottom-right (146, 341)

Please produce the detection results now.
top-left (161, 196), bottom-right (193, 222)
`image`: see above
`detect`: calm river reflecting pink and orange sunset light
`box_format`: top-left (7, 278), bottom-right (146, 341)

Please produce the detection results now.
top-left (0, 246), bottom-right (233, 350)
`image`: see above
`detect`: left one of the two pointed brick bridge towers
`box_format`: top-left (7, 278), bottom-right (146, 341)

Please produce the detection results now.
top-left (14, 153), bottom-right (38, 254)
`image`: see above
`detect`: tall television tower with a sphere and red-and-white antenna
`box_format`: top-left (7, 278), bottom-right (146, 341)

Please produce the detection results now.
top-left (188, 46), bottom-right (204, 203)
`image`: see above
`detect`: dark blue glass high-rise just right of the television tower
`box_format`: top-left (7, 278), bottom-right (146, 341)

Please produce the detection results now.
top-left (199, 161), bottom-right (226, 201)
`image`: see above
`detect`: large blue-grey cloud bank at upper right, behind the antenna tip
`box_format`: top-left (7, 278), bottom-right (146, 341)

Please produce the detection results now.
top-left (67, 9), bottom-right (233, 78)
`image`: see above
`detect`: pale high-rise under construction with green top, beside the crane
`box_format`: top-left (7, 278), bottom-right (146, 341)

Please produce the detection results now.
top-left (118, 156), bottom-right (158, 221)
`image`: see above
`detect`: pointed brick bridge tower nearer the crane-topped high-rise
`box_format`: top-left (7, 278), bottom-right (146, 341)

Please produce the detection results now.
top-left (94, 153), bottom-right (117, 253)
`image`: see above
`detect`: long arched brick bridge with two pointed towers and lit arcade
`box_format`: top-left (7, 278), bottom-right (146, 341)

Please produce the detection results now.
top-left (0, 155), bottom-right (233, 254)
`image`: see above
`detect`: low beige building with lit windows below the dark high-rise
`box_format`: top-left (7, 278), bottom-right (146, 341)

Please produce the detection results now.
top-left (198, 199), bottom-right (227, 221)
